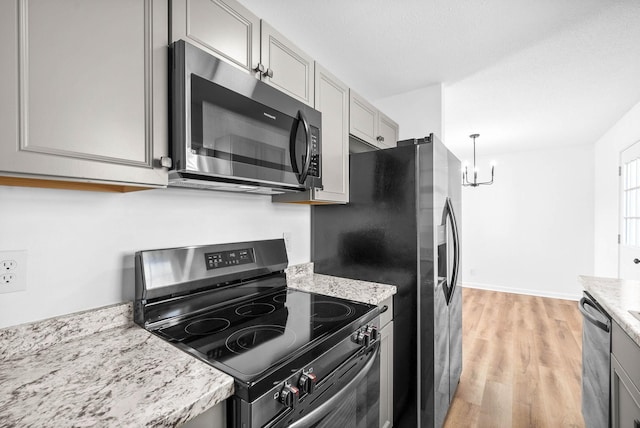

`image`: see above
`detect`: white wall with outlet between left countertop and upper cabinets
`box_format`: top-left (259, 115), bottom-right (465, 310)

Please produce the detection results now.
top-left (0, 186), bottom-right (310, 327)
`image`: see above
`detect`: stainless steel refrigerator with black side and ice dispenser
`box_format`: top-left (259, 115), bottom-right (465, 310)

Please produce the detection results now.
top-left (311, 138), bottom-right (462, 428)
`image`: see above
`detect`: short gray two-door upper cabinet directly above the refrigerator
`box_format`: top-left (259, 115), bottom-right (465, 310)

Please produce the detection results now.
top-left (349, 90), bottom-right (399, 149)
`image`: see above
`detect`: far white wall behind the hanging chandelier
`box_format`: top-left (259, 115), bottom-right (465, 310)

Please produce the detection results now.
top-left (461, 145), bottom-right (594, 299)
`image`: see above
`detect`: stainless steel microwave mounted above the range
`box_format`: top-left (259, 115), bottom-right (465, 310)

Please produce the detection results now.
top-left (169, 40), bottom-right (322, 194)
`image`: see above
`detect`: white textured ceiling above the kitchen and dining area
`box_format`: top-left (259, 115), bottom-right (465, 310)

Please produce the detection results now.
top-left (240, 0), bottom-right (640, 156)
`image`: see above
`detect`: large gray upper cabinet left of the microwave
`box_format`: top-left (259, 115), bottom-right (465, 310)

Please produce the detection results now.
top-left (0, 0), bottom-right (168, 190)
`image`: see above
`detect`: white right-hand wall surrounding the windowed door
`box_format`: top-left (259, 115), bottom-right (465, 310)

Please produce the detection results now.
top-left (594, 103), bottom-right (640, 278)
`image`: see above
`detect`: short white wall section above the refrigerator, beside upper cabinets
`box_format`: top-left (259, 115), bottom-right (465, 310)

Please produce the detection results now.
top-left (374, 84), bottom-right (445, 141)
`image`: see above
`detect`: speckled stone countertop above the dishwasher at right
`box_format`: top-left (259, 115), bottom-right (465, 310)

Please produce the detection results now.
top-left (579, 276), bottom-right (640, 346)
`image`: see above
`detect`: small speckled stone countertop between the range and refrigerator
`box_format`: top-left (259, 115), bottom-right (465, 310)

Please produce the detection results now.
top-left (287, 263), bottom-right (397, 305)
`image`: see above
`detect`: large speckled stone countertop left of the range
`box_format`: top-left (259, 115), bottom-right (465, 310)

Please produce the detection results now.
top-left (0, 303), bottom-right (233, 427)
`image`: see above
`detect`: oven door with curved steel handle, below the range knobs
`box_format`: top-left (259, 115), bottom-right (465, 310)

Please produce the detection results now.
top-left (265, 344), bottom-right (380, 428)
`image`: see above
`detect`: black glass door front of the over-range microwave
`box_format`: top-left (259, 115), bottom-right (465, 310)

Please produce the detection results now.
top-left (190, 74), bottom-right (306, 185)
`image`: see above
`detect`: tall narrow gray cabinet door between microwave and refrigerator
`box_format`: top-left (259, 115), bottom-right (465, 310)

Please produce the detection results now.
top-left (315, 63), bottom-right (349, 203)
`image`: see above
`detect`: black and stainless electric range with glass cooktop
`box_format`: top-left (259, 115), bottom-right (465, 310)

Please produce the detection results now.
top-left (134, 240), bottom-right (379, 428)
